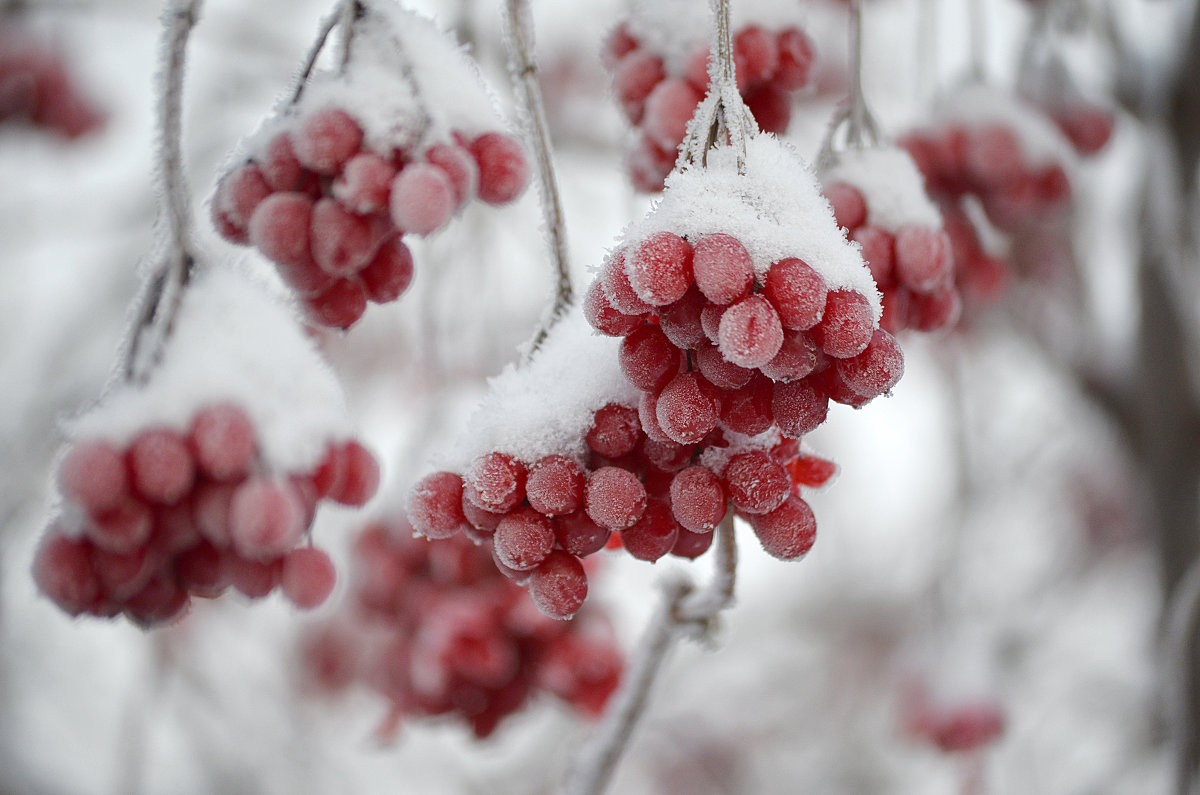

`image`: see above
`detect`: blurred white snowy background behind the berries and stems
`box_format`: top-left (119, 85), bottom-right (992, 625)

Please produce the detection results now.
top-left (0, 0), bottom-right (1171, 795)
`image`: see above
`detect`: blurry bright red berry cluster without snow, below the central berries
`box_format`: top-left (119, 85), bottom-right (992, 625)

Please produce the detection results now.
top-left (304, 519), bottom-right (624, 737)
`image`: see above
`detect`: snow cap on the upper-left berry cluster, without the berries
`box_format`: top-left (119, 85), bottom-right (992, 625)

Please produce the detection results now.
top-left (242, 0), bottom-right (503, 163)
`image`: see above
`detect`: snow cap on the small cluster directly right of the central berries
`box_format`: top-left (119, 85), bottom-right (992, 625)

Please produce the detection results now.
top-left (823, 147), bottom-right (942, 233)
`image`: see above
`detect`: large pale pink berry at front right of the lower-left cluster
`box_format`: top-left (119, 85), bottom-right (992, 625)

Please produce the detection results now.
top-left (229, 479), bottom-right (305, 561)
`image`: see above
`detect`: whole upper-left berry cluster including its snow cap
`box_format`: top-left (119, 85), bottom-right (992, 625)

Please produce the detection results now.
top-left (212, 4), bottom-right (529, 329)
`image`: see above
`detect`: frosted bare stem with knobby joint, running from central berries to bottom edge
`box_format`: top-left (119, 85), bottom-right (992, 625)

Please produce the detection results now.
top-left (564, 512), bottom-right (738, 795)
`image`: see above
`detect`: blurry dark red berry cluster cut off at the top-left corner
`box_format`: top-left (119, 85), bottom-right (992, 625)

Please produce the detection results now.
top-left (0, 25), bottom-right (104, 138)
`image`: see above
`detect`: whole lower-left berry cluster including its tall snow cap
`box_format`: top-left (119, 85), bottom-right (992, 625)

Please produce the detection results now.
top-left (34, 271), bottom-right (379, 627)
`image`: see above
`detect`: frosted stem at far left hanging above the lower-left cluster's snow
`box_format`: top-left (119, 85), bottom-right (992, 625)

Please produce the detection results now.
top-left (124, 0), bottom-right (202, 382)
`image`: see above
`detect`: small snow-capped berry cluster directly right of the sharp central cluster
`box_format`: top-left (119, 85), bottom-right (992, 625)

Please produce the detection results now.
top-left (822, 148), bottom-right (961, 334)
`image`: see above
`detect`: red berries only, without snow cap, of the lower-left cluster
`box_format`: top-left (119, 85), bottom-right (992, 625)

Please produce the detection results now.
top-left (34, 404), bottom-right (379, 627)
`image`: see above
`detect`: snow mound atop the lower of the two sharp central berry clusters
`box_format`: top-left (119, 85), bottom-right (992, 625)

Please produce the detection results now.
top-left (437, 305), bottom-right (641, 472)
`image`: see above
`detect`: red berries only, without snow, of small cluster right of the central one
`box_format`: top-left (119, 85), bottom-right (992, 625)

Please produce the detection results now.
top-left (824, 174), bottom-right (962, 334)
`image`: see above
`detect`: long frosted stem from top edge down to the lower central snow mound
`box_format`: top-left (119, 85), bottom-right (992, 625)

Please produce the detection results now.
top-left (504, 0), bottom-right (575, 355)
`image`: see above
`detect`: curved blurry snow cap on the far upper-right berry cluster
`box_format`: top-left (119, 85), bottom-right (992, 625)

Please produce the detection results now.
top-left (934, 84), bottom-right (1079, 173)
